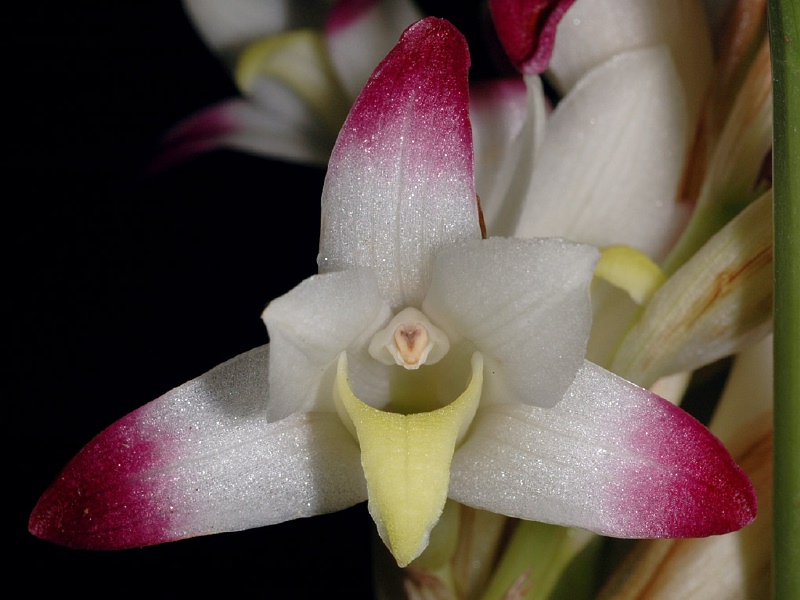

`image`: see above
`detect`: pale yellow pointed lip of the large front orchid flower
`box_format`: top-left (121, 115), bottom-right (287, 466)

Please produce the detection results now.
top-left (334, 352), bottom-right (483, 567)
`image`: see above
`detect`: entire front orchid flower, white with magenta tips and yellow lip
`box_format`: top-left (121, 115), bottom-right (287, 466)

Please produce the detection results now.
top-left (30, 18), bottom-right (756, 566)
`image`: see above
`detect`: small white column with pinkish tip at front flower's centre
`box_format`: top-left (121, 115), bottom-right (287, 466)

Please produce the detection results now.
top-left (369, 307), bottom-right (450, 369)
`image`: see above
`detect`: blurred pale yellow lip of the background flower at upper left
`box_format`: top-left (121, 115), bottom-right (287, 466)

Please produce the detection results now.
top-left (234, 29), bottom-right (349, 132)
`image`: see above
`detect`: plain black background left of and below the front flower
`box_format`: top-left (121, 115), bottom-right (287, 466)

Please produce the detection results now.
top-left (3, 0), bottom-right (494, 598)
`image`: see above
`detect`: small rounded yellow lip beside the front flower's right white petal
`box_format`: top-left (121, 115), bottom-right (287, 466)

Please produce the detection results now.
top-left (594, 246), bottom-right (666, 304)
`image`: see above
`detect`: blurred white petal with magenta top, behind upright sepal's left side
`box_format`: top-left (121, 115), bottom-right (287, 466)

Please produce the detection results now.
top-left (325, 0), bottom-right (423, 100)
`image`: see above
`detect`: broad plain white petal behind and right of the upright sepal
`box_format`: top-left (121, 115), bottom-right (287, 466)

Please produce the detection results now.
top-left (516, 46), bottom-right (687, 258)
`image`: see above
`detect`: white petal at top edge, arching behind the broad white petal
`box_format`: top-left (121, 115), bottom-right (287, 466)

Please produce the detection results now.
top-left (548, 0), bottom-right (713, 132)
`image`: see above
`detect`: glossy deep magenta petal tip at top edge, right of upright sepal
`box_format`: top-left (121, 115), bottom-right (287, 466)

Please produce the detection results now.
top-left (489, 0), bottom-right (575, 75)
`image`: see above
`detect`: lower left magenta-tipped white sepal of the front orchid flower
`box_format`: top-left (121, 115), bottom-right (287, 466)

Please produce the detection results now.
top-left (30, 346), bottom-right (367, 550)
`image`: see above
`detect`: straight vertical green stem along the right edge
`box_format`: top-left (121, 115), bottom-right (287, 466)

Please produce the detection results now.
top-left (768, 0), bottom-right (800, 598)
